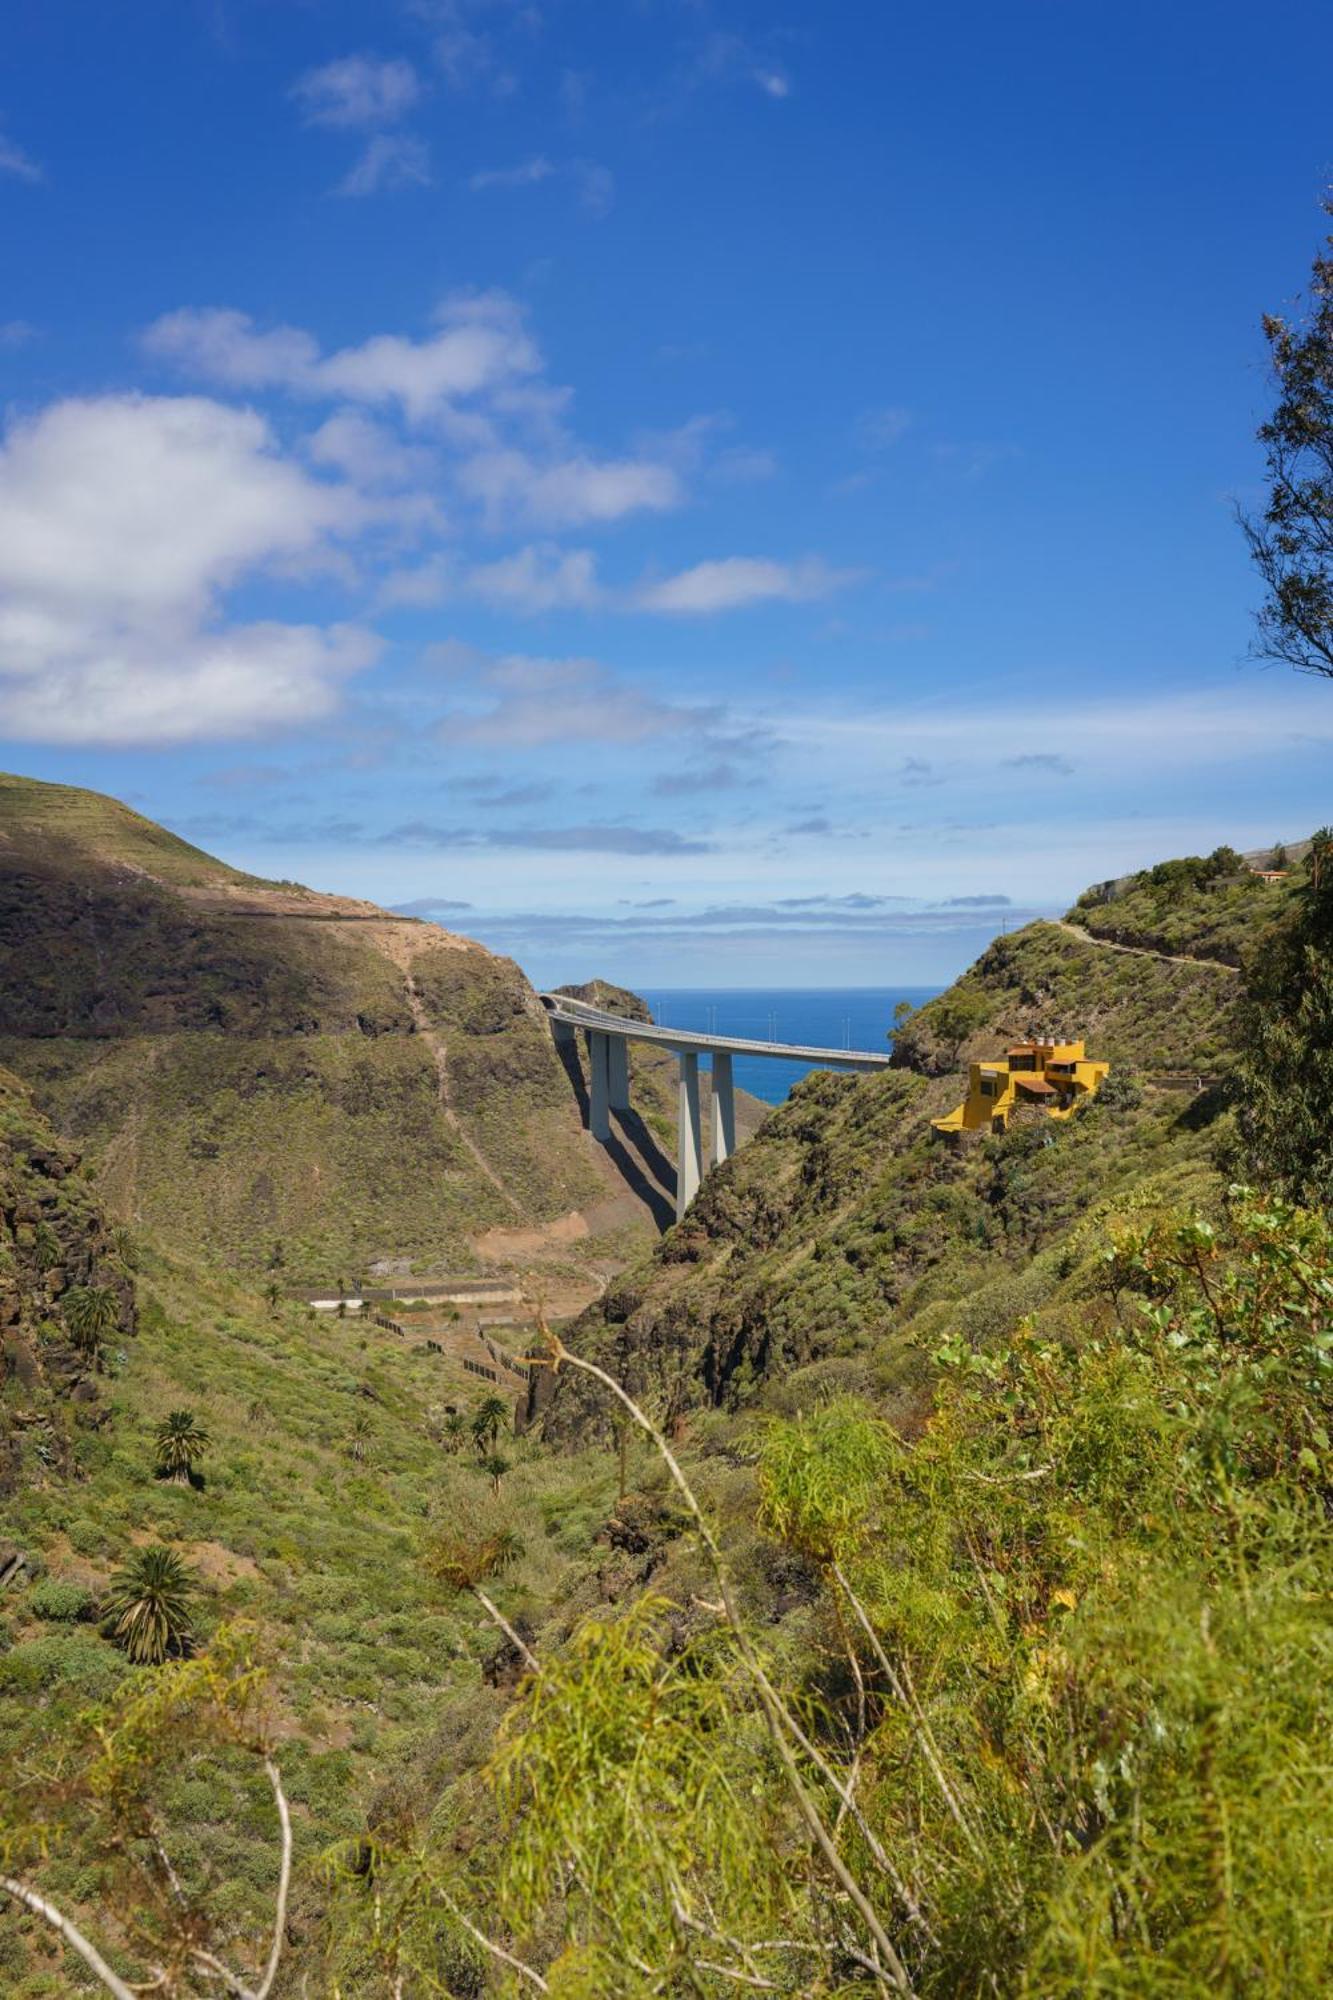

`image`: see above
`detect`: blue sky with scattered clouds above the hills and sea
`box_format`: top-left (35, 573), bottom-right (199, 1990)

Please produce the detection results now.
top-left (0, 0), bottom-right (1333, 986)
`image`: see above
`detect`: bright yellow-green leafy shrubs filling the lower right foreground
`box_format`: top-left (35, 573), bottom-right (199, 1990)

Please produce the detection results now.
top-left (344, 1196), bottom-right (1333, 2000)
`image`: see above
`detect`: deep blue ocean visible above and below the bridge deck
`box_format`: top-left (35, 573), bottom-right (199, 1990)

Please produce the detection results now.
top-left (644, 986), bottom-right (941, 1104)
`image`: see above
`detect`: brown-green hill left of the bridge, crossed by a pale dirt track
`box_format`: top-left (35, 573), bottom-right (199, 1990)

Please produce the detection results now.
top-left (0, 776), bottom-right (675, 1296)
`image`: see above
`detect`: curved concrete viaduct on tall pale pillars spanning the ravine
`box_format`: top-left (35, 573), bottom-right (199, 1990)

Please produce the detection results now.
top-left (540, 994), bottom-right (891, 1222)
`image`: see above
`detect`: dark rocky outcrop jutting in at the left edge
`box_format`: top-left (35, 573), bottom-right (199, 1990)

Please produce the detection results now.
top-left (0, 1070), bottom-right (134, 1494)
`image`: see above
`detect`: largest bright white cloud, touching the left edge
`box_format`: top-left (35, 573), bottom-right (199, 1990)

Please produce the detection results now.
top-left (0, 396), bottom-right (378, 744)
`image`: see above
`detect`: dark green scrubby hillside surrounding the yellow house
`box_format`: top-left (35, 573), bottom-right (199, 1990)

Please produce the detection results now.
top-left (548, 864), bottom-right (1248, 1436)
